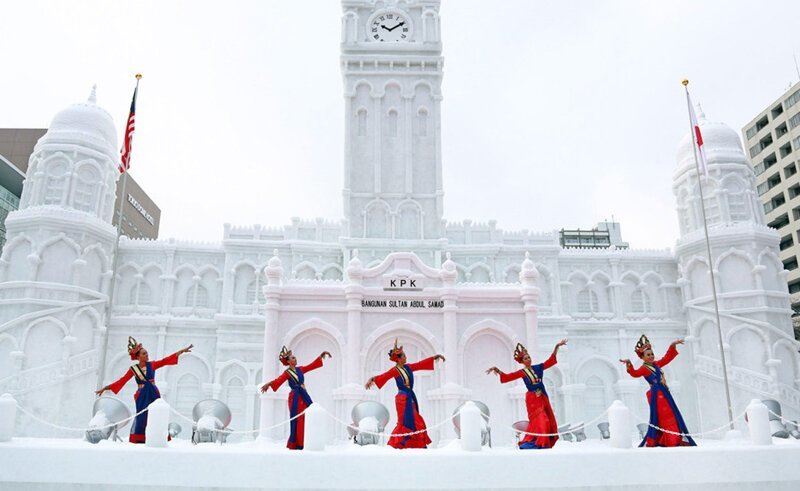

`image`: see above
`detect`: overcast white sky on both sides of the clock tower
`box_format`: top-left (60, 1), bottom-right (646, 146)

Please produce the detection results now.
top-left (0, 0), bottom-right (800, 248)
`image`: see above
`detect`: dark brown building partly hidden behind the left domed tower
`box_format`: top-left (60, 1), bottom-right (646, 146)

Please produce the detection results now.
top-left (0, 128), bottom-right (161, 241)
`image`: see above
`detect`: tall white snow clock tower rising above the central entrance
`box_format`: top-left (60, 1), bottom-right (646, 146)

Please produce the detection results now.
top-left (341, 0), bottom-right (443, 241)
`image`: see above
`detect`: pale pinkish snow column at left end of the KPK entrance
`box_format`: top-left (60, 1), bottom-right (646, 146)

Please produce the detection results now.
top-left (258, 249), bottom-right (283, 439)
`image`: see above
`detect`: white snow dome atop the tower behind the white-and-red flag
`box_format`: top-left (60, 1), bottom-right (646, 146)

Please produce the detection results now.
top-left (676, 118), bottom-right (750, 176)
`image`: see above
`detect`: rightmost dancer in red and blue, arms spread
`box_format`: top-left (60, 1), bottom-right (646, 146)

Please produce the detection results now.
top-left (620, 334), bottom-right (697, 447)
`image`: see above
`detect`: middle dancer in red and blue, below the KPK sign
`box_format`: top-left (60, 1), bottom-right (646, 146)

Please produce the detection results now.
top-left (365, 339), bottom-right (445, 449)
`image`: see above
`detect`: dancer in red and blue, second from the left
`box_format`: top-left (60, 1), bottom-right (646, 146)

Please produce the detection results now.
top-left (261, 346), bottom-right (331, 450)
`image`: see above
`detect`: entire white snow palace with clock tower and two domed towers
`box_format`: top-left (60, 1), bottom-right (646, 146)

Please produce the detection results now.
top-left (0, 0), bottom-right (800, 444)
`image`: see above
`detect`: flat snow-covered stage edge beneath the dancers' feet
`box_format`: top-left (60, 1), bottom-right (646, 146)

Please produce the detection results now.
top-left (0, 438), bottom-right (800, 491)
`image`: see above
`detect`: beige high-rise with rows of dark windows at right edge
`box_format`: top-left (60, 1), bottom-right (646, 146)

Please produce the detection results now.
top-left (742, 83), bottom-right (800, 339)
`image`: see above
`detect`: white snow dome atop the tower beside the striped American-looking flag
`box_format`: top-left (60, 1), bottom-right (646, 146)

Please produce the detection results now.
top-left (47, 92), bottom-right (117, 153)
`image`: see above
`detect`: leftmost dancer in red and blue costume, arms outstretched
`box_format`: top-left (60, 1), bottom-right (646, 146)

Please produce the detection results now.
top-left (95, 336), bottom-right (193, 443)
